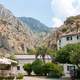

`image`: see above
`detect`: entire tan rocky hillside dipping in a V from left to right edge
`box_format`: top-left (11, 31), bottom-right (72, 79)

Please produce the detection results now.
top-left (0, 4), bottom-right (80, 55)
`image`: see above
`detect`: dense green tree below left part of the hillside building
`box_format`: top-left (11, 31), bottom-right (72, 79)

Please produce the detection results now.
top-left (56, 45), bottom-right (73, 63)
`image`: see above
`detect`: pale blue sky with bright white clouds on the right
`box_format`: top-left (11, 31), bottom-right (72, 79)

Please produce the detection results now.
top-left (0, 0), bottom-right (80, 27)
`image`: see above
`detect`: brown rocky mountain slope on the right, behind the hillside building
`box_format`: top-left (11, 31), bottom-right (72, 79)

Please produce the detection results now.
top-left (43, 15), bottom-right (80, 50)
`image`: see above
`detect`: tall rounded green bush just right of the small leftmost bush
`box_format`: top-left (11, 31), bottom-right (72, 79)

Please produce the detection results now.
top-left (32, 59), bottom-right (43, 75)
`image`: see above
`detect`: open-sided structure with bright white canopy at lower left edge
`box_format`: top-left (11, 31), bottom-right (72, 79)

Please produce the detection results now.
top-left (0, 57), bottom-right (17, 77)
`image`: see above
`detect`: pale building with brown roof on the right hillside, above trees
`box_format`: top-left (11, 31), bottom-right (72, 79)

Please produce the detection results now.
top-left (57, 32), bottom-right (80, 49)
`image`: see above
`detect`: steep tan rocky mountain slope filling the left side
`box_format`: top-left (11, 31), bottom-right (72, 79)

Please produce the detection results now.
top-left (0, 4), bottom-right (36, 54)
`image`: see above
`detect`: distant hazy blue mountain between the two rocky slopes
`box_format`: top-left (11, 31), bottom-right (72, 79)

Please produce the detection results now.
top-left (19, 17), bottom-right (52, 37)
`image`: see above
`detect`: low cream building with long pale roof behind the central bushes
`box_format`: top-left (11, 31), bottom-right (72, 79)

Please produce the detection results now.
top-left (15, 55), bottom-right (52, 74)
